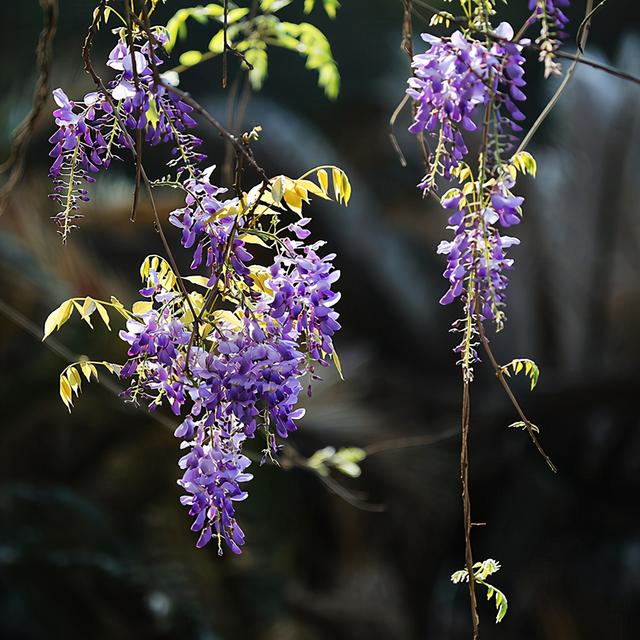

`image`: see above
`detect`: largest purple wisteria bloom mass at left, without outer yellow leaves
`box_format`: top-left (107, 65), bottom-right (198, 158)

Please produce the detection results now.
top-left (120, 169), bottom-right (340, 553)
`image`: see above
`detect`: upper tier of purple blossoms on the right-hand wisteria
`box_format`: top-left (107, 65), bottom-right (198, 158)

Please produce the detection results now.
top-left (407, 22), bottom-right (526, 191)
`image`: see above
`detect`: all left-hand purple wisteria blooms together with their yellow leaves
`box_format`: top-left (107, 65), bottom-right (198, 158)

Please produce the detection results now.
top-left (45, 17), bottom-right (351, 553)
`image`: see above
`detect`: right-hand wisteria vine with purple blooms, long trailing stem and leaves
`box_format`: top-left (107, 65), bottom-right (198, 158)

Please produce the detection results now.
top-left (405, 0), bottom-right (572, 624)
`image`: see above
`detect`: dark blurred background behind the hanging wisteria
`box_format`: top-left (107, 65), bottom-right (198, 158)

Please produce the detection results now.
top-left (0, 0), bottom-right (640, 640)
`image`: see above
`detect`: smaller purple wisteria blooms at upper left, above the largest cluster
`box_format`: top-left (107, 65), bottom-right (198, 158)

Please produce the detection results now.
top-left (50, 26), bottom-right (205, 239)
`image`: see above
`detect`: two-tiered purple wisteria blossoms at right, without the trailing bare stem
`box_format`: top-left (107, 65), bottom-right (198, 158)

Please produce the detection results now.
top-left (407, 22), bottom-right (535, 377)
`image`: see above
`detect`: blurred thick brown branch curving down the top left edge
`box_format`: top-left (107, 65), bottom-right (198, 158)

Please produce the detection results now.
top-left (0, 0), bottom-right (58, 216)
